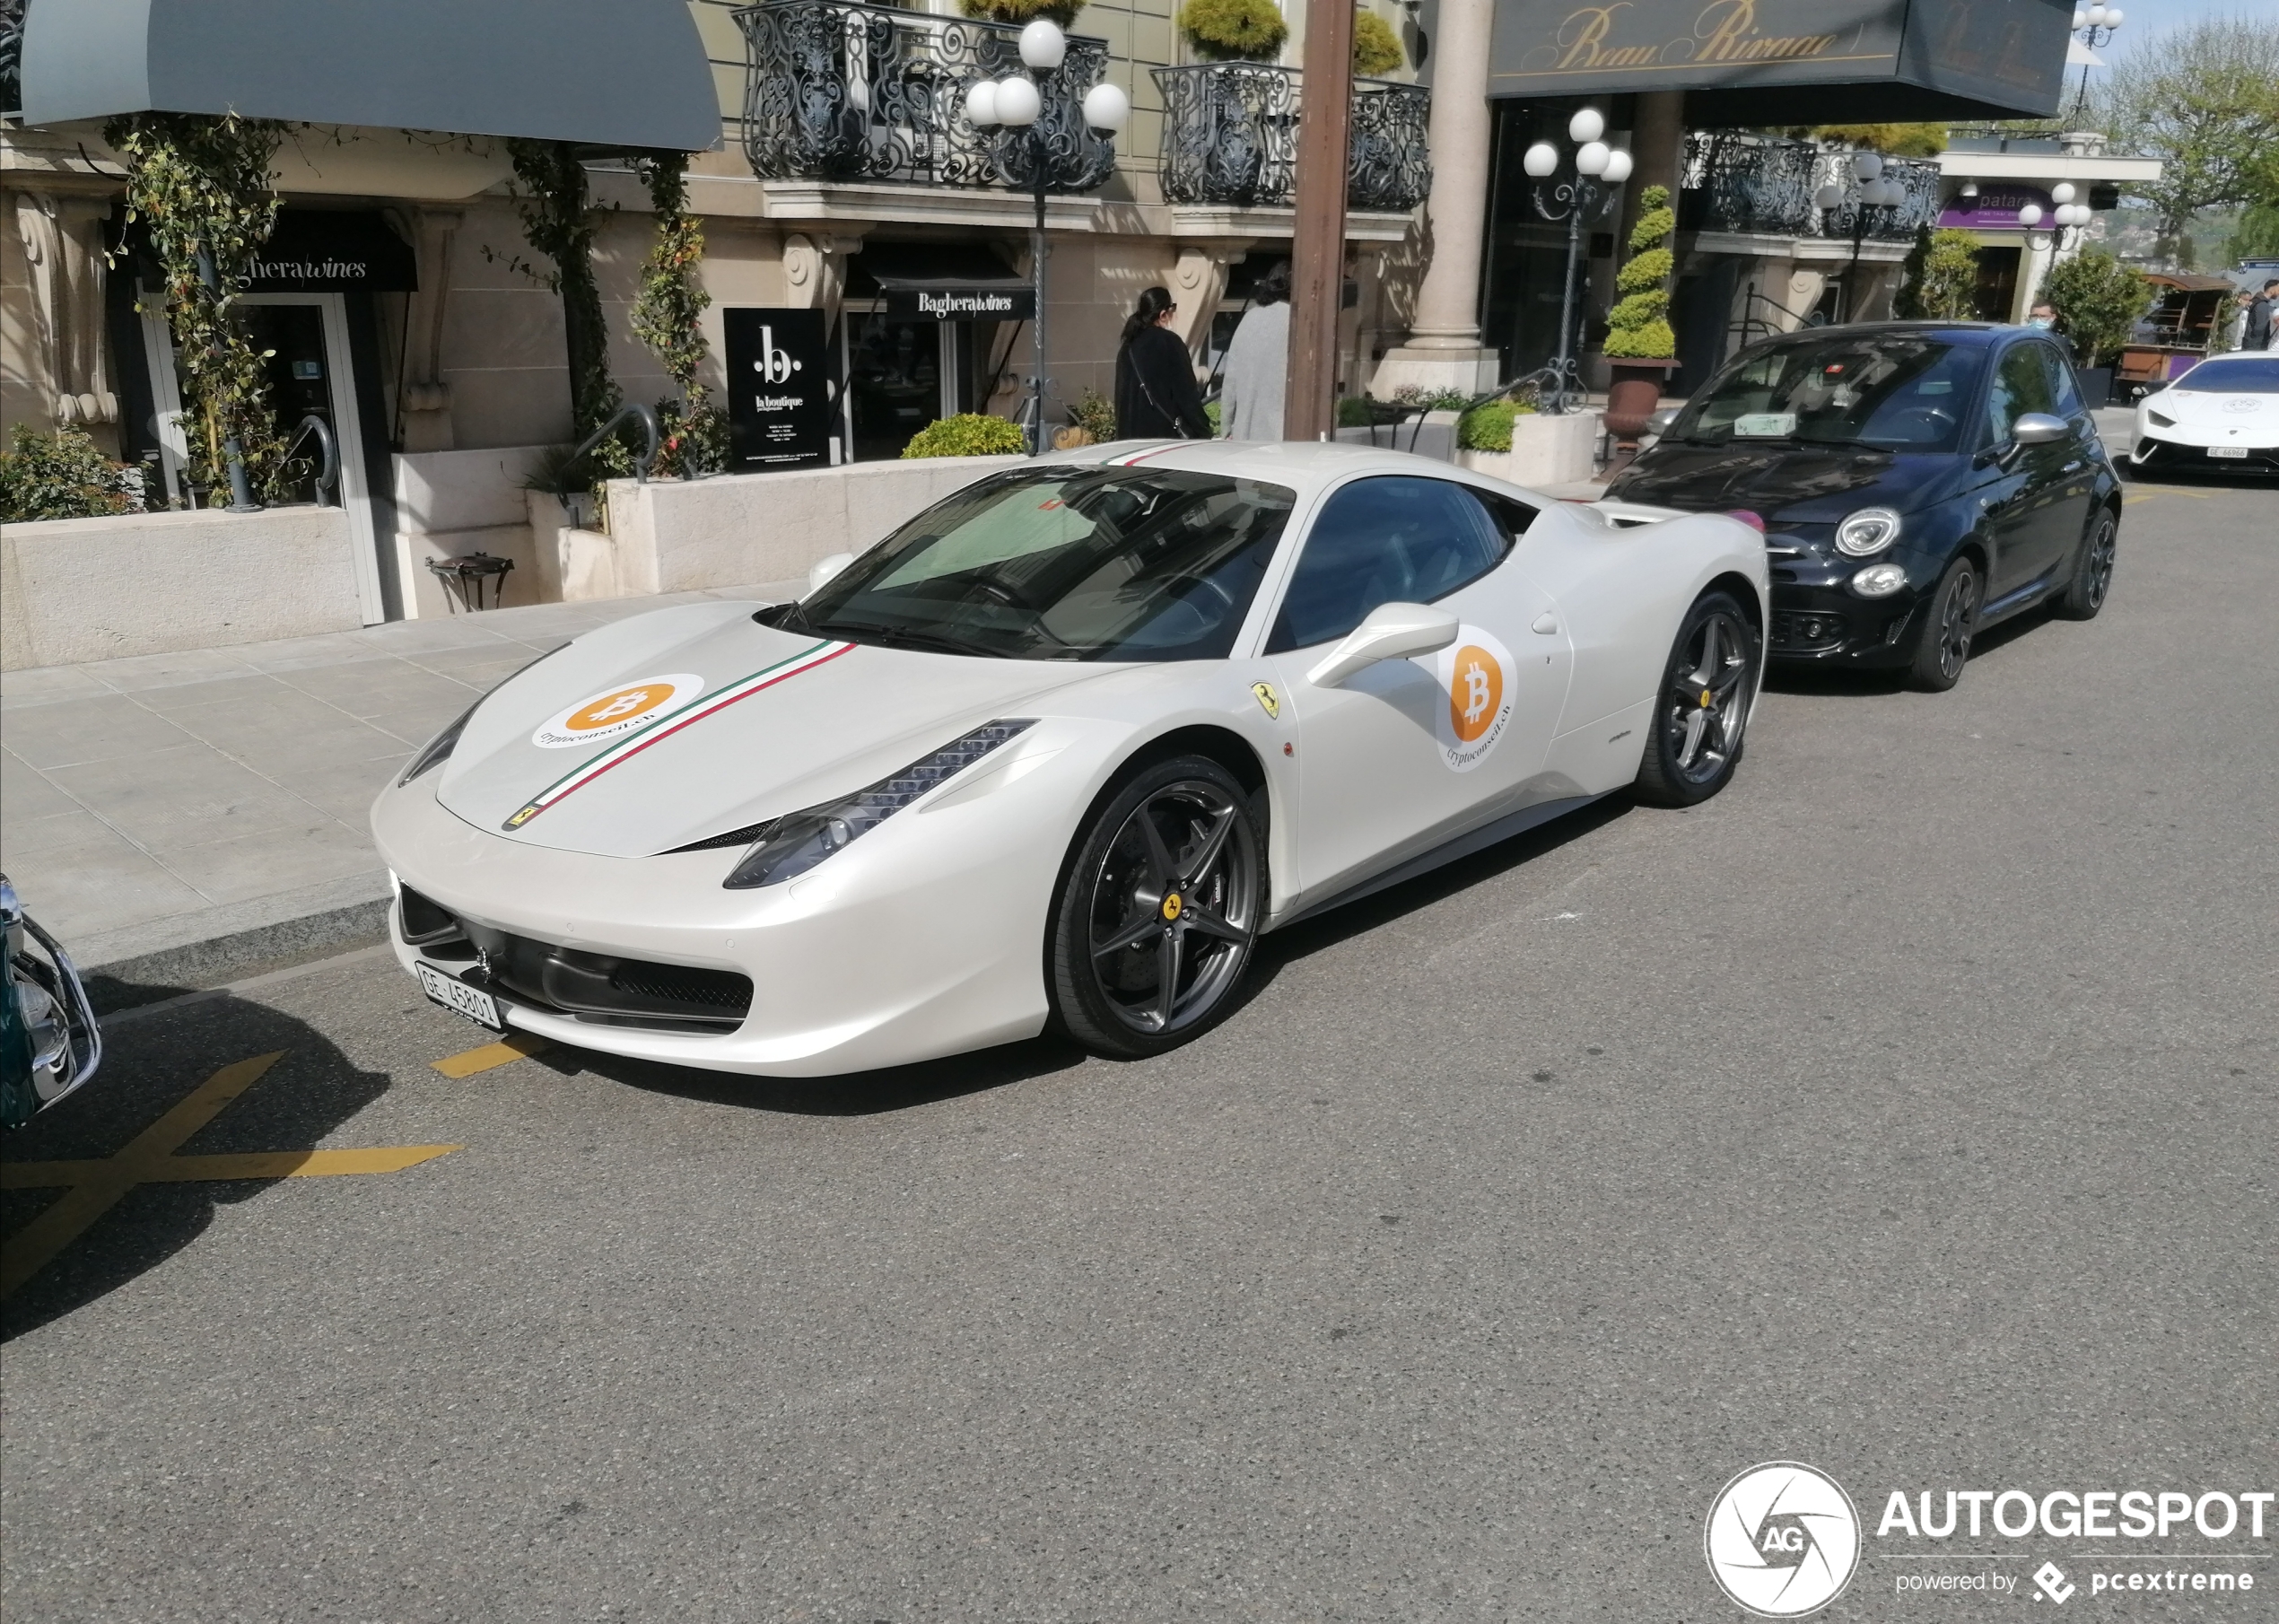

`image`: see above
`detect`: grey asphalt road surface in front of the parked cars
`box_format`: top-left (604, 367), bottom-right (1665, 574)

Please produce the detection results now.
top-left (0, 476), bottom-right (2279, 1624)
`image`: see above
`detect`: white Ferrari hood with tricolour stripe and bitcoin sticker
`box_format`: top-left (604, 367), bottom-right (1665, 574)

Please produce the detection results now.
top-left (435, 604), bottom-right (1098, 857)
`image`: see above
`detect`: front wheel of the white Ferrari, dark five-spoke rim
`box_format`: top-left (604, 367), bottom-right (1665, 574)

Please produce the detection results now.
top-left (1051, 756), bottom-right (1265, 1059)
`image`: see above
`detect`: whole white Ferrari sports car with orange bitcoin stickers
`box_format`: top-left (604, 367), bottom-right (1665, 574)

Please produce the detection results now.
top-left (371, 441), bottom-right (1767, 1078)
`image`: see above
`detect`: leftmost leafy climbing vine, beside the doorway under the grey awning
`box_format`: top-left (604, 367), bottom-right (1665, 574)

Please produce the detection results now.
top-left (102, 111), bottom-right (290, 501)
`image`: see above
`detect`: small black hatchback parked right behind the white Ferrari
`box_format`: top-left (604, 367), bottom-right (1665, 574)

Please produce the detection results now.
top-left (1607, 321), bottom-right (2122, 690)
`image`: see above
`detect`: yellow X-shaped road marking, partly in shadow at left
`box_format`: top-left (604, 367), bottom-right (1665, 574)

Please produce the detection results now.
top-left (0, 1050), bottom-right (458, 1296)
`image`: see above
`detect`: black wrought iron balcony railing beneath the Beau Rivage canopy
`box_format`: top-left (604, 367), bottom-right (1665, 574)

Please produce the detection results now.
top-left (1677, 130), bottom-right (1940, 241)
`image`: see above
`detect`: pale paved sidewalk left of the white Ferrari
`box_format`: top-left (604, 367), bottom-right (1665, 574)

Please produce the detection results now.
top-left (0, 583), bottom-right (805, 965)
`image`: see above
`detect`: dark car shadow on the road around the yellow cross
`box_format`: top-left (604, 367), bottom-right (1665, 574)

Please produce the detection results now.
top-left (0, 998), bottom-right (389, 1341)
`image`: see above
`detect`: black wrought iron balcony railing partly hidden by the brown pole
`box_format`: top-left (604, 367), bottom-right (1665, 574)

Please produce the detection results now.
top-left (1153, 62), bottom-right (1431, 212)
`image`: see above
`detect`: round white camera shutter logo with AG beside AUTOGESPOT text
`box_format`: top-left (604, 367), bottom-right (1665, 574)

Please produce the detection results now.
top-left (1702, 1460), bottom-right (1860, 1620)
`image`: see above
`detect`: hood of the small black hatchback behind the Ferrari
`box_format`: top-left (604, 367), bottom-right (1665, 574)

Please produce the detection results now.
top-left (1607, 441), bottom-right (1967, 524)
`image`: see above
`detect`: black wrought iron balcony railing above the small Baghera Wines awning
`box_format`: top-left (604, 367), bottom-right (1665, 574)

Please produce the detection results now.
top-left (736, 0), bottom-right (1117, 191)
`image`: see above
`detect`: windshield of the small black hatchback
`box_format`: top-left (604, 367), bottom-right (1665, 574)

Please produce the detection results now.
top-left (1671, 330), bottom-right (1983, 451)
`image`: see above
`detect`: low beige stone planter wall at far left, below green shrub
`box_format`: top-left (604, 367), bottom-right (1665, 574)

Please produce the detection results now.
top-left (0, 508), bottom-right (364, 672)
